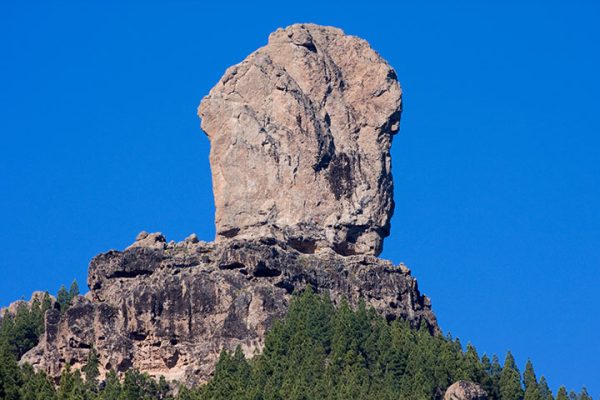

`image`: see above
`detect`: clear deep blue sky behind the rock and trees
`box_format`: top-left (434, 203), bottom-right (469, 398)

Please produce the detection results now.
top-left (0, 0), bottom-right (600, 398)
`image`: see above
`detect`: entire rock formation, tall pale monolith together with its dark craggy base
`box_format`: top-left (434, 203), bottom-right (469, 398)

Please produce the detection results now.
top-left (23, 24), bottom-right (438, 383)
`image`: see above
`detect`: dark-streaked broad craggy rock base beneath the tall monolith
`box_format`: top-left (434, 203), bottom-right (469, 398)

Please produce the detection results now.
top-left (23, 233), bottom-right (438, 384)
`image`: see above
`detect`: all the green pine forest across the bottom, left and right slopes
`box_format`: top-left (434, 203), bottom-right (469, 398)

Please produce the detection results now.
top-left (0, 285), bottom-right (591, 400)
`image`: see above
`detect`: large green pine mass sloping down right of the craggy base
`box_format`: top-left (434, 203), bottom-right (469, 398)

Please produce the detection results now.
top-left (179, 290), bottom-right (596, 400)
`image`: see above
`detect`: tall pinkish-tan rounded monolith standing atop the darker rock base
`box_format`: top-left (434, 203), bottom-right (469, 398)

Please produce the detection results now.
top-left (198, 24), bottom-right (401, 255)
